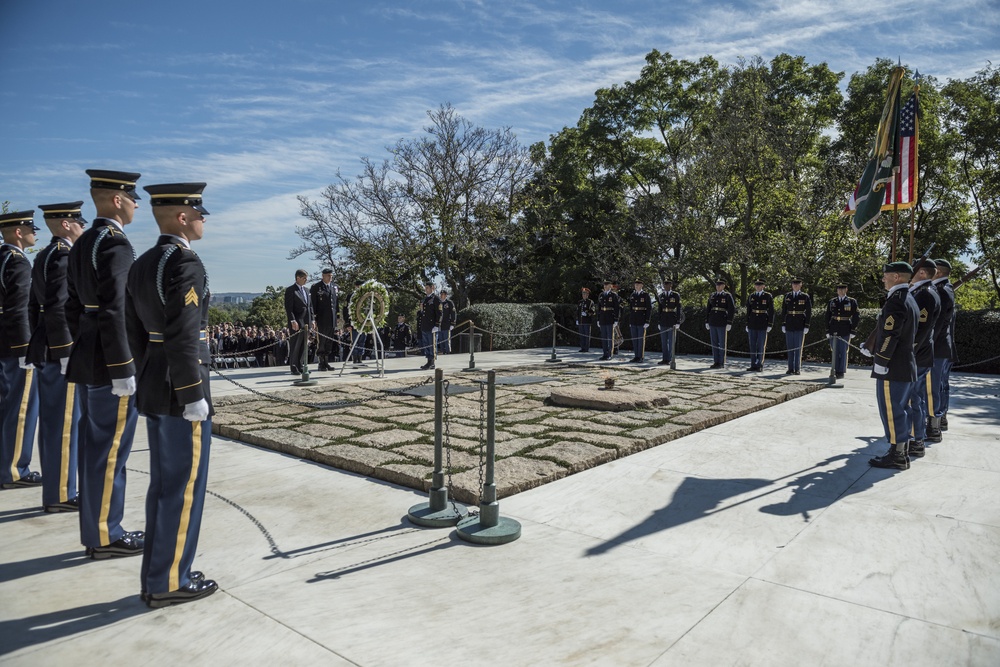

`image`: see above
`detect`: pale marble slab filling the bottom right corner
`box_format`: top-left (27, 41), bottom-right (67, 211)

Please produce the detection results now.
top-left (652, 579), bottom-right (1000, 667)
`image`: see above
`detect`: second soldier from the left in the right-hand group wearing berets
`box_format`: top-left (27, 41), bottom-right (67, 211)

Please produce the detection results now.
top-left (907, 259), bottom-right (941, 458)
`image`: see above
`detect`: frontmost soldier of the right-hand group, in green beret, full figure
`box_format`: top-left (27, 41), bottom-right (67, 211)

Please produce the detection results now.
top-left (861, 262), bottom-right (920, 470)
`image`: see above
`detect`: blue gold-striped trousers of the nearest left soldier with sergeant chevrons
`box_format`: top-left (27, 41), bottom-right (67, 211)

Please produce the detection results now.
top-left (141, 415), bottom-right (212, 593)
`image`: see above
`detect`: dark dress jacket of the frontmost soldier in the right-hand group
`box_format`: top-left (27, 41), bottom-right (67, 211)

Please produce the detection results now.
top-left (872, 286), bottom-right (920, 382)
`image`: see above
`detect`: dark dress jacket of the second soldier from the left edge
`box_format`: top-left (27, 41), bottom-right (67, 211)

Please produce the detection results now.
top-left (28, 237), bottom-right (73, 365)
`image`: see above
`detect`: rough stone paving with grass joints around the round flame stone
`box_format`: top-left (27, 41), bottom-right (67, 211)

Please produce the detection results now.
top-left (212, 364), bottom-right (822, 504)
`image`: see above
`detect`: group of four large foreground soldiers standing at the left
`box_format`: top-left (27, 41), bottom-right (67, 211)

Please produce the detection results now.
top-left (0, 169), bottom-right (218, 607)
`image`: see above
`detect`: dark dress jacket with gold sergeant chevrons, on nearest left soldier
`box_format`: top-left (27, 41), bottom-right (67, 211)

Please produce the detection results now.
top-left (125, 234), bottom-right (213, 417)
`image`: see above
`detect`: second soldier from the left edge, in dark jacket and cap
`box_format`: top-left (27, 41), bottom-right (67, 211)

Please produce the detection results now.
top-left (28, 201), bottom-right (87, 512)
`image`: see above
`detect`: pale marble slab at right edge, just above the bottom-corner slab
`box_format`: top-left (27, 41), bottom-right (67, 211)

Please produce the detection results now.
top-left (755, 500), bottom-right (1000, 639)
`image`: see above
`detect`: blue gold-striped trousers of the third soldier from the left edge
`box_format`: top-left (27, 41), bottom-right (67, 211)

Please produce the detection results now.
top-left (78, 384), bottom-right (139, 547)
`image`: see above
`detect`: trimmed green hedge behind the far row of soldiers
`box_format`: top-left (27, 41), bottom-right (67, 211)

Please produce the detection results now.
top-left (458, 303), bottom-right (1000, 374)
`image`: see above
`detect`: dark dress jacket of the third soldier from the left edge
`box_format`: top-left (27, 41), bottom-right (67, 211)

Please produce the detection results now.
top-left (66, 218), bottom-right (136, 386)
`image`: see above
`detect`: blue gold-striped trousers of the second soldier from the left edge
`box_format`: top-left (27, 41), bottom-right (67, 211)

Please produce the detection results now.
top-left (37, 361), bottom-right (80, 506)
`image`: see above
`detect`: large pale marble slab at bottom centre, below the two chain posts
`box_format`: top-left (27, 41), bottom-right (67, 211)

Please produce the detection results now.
top-left (225, 523), bottom-right (742, 667)
